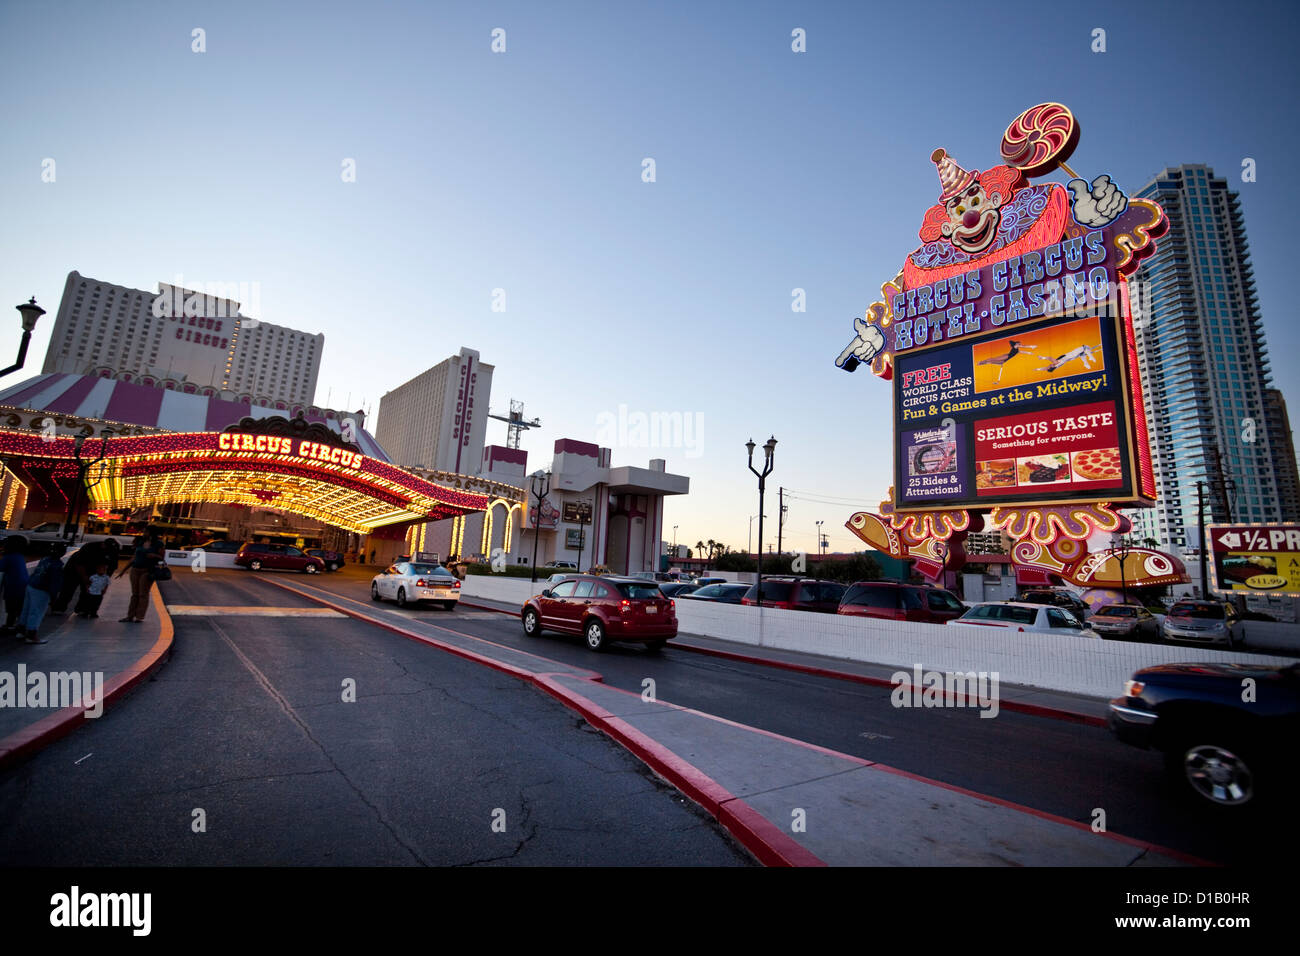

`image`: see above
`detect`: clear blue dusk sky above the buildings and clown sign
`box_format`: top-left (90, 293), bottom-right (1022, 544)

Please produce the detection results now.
top-left (0, 0), bottom-right (1300, 551)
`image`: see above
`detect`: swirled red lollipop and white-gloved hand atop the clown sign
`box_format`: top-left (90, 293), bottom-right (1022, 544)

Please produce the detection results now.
top-left (1002, 103), bottom-right (1128, 229)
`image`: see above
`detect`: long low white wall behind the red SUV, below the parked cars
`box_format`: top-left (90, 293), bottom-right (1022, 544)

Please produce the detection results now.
top-left (462, 575), bottom-right (1300, 697)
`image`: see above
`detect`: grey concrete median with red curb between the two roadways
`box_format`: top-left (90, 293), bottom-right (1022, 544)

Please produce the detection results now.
top-left (274, 580), bottom-right (1204, 866)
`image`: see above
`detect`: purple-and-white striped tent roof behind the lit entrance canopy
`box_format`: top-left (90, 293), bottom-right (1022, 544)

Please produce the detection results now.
top-left (0, 372), bottom-right (391, 462)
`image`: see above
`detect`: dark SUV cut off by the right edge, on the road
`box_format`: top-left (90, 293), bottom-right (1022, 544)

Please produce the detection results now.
top-left (1110, 663), bottom-right (1300, 808)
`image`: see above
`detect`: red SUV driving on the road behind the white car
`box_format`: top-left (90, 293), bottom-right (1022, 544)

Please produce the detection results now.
top-left (520, 575), bottom-right (677, 650)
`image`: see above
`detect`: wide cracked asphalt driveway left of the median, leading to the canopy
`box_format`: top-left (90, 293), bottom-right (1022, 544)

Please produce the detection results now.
top-left (0, 572), bottom-right (753, 866)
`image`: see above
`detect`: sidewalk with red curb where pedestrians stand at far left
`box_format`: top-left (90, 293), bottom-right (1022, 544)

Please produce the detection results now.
top-left (0, 575), bottom-right (173, 769)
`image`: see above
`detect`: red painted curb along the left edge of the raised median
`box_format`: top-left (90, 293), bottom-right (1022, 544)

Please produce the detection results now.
top-left (270, 580), bottom-right (826, 866)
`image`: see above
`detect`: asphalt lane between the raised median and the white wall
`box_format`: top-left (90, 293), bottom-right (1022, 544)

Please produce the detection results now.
top-left (301, 567), bottom-right (1277, 864)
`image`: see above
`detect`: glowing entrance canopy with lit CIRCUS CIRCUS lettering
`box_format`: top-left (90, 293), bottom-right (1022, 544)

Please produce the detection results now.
top-left (0, 429), bottom-right (489, 535)
